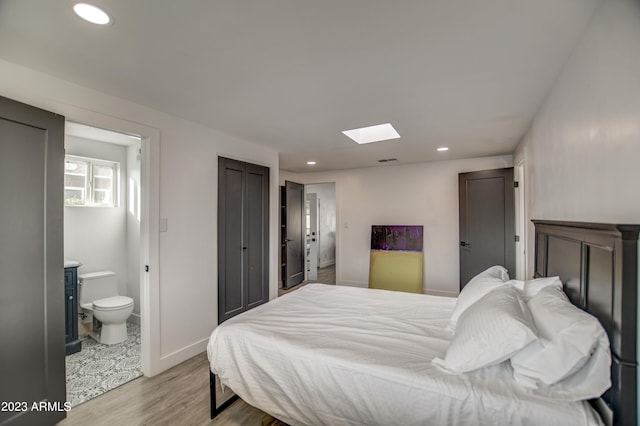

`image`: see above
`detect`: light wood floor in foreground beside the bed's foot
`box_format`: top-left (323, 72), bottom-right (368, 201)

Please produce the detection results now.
top-left (58, 353), bottom-right (286, 426)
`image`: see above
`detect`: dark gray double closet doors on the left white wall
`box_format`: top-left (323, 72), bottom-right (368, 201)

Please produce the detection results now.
top-left (218, 157), bottom-right (269, 323)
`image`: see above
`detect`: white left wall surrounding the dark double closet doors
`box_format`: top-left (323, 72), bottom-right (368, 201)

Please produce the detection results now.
top-left (0, 60), bottom-right (279, 374)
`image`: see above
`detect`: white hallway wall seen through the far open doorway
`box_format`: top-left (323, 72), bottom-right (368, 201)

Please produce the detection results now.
top-left (304, 182), bottom-right (336, 268)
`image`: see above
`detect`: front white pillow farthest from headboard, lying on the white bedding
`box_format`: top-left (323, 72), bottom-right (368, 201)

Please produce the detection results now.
top-left (432, 285), bottom-right (536, 374)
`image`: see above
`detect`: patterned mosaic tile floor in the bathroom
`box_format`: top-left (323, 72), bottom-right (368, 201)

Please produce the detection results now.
top-left (66, 323), bottom-right (142, 407)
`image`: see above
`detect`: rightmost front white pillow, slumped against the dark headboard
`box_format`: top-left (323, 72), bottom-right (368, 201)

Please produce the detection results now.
top-left (511, 280), bottom-right (611, 396)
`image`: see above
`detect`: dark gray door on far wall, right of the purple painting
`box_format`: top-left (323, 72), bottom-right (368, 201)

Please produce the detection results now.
top-left (458, 168), bottom-right (516, 290)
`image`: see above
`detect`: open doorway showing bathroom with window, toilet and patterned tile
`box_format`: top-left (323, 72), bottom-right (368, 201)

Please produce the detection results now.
top-left (64, 121), bottom-right (143, 407)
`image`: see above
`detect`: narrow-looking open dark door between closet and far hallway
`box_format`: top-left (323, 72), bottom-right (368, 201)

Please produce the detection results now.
top-left (284, 181), bottom-right (305, 288)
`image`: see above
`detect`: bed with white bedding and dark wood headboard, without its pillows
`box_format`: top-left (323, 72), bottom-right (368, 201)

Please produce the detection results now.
top-left (208, 221), bottom-right (640, 425)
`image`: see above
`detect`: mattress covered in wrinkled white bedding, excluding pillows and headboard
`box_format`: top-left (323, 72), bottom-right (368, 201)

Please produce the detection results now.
top-left (207, 284), bottom-right (601, 426)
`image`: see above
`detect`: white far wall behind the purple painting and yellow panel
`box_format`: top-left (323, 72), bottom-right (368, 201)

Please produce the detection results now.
top-left (280, 155), bottom-right (512, 296)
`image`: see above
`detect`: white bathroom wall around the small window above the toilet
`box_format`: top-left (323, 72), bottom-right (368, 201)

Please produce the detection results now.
top-left (64, 136), bottom-right (129, 299)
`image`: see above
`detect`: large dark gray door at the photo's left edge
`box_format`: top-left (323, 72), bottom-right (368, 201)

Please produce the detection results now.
top-left (0, 97), bottom-right (66, 425)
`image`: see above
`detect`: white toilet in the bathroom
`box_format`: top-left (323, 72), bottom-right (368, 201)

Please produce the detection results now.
top-left (78, 271), bottom-right (133, 345)
